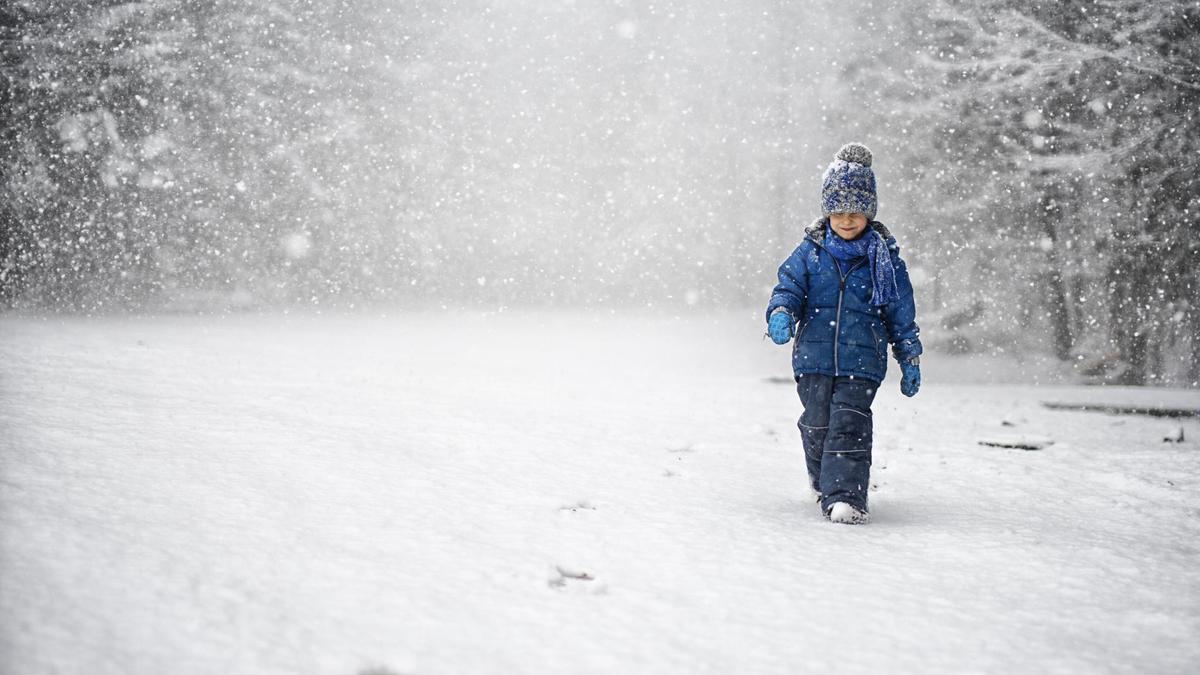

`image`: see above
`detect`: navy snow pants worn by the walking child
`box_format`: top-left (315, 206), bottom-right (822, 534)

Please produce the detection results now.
top-left (796, 375), bottom-right (880, 513)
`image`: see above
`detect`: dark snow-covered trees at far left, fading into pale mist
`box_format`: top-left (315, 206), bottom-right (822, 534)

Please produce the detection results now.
top-left (0, 0), bottom-right (432, 311)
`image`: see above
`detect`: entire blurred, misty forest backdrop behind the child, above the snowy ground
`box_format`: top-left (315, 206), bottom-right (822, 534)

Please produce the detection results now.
top-left (0, 0), bottom-right (1200, 386)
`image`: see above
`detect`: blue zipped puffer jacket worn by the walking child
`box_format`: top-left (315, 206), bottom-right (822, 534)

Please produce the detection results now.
top-left (767, 219), bottom-right (922, 382)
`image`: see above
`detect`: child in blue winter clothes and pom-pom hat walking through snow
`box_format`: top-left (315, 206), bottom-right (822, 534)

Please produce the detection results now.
top-left (767, 143), bottom-right (922, 524)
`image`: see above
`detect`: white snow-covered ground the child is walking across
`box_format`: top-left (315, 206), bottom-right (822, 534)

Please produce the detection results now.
top-left (0, 310), bottom-right (1200, 675)
